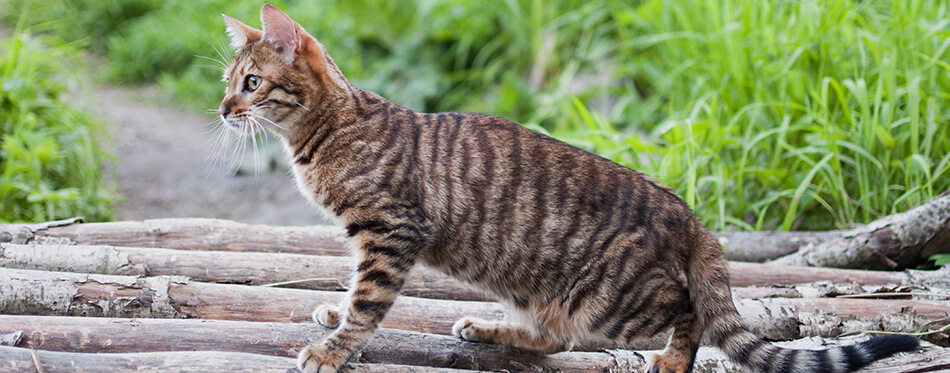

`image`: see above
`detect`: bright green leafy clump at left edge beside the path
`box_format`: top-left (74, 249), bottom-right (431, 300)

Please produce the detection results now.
top-left (0, 34), bottom-right (115, 222)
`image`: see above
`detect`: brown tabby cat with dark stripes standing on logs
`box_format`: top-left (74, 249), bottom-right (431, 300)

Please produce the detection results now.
top-left (219, 4), bottom-right (919, 372)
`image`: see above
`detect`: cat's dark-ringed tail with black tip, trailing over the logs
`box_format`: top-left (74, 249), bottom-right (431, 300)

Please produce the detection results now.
top-left (687, 231), bottom-right (920, 372)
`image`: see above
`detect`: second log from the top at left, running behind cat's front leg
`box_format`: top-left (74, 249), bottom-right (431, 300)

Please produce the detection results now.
top-left (0, 244), bottom-right (491, 301)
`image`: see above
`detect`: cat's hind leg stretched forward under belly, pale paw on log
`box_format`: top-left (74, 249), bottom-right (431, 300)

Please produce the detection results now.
top-left (452, 317), bottom-right (574, 354)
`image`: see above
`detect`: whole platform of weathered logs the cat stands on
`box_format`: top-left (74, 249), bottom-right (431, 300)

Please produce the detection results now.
top-left (0, 195), bottom-right (950, 372)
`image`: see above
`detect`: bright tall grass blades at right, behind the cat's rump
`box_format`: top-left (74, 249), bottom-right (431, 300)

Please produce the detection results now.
top-left (561, 0), bottom-right (950, 230)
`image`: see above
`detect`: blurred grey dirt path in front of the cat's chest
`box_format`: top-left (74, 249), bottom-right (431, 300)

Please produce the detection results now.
top-left (87, 86), bottom-right (326, 225)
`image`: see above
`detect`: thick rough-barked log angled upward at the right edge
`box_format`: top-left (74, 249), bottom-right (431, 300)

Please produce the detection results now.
top-left (773, 192), bottom-right (950, 270)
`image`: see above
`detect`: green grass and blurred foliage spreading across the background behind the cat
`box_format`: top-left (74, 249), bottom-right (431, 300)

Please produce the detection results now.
top-left (0, 0), bottom-right (950, 230)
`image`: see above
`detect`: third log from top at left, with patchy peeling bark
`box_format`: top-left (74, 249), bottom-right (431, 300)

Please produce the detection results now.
top-left (0, 269), bottom-right (505, 334)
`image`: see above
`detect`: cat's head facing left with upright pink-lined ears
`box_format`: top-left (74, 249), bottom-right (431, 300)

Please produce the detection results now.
top-left (218, 4), bottom-right (350, 139)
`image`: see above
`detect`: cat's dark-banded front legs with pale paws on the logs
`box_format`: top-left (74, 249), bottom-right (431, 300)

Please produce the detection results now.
top-left (297, 225), bottom-right (418, 373)
